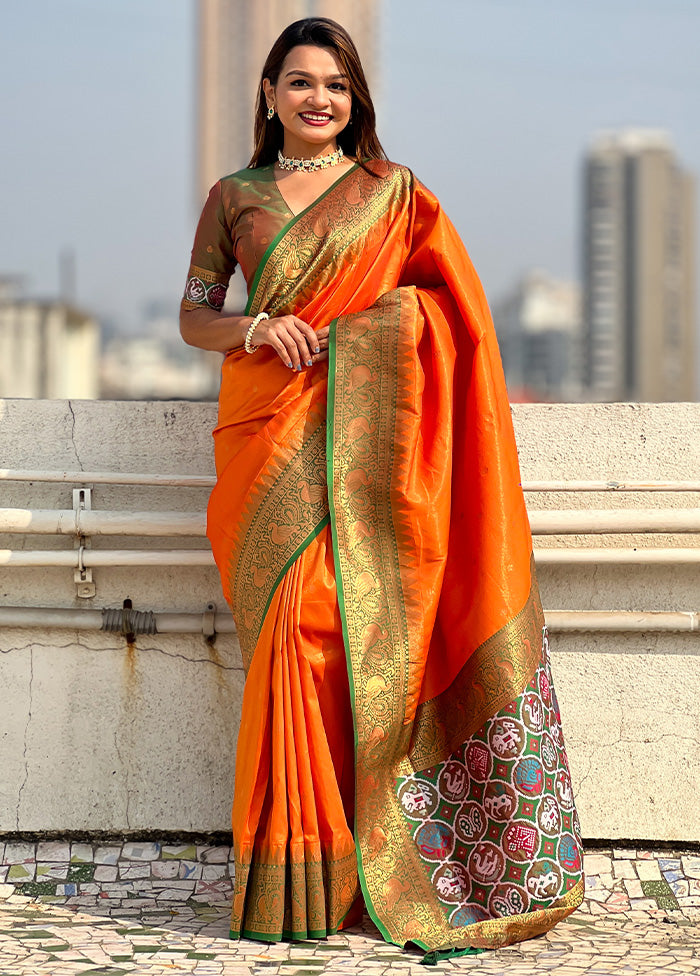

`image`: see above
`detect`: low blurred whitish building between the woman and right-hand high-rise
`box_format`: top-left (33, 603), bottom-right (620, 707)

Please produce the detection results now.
top-left (493, 271), bottom-right (581, 401)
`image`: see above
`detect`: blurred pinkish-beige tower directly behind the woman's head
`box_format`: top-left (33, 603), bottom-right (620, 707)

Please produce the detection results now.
top-left (195, 0), bottom-right (382, 207)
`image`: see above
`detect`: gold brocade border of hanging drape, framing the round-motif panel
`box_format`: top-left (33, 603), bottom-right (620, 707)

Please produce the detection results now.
top-left (329, 289), bottom-right (583, 950)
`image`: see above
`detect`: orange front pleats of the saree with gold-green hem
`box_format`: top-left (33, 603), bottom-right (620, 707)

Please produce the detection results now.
top-left (231, 529), bottom-right (357, 940)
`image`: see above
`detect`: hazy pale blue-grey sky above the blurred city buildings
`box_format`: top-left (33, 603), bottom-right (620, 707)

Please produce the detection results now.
top-left (0, 0), bottom-right (700, 328)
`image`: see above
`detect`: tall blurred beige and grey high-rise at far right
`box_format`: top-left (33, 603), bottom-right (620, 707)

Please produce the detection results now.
top-left (583, 129), bottom-right (696, 402)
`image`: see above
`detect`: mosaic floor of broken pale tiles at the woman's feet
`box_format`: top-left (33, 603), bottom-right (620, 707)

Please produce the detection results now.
top-left (0, 843), bottom-right (700, 976)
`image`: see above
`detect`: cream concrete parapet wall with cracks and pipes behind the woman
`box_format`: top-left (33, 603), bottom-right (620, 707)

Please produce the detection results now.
top-left (0, 400), bottom-right (700, 842)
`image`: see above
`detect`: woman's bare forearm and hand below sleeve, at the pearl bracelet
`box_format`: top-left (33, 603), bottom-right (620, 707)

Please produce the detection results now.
top-left (180, 308), bottom-right (328, 370)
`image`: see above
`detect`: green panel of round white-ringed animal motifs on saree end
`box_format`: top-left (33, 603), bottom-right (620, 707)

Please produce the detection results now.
top-left (396, 629), bottom-right (582, 927)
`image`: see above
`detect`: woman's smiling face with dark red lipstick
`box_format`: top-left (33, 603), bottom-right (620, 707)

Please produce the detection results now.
top-left (263, 44), bottom-right (352, 156)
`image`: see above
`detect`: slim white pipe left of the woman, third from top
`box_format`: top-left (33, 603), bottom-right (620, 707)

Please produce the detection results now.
top-left (0, 548), bottom-right (215, 569)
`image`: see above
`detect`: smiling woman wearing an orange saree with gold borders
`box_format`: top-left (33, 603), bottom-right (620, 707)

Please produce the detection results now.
top-left (181, 18), bottom-right (583, 952)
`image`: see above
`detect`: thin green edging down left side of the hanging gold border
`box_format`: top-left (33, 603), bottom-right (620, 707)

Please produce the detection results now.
top-left (326, 318), bottom-right (400, 945)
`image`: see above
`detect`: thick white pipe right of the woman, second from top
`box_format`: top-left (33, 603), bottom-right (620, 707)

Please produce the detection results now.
top-left (529, 508), bottom-right (700, 535)
